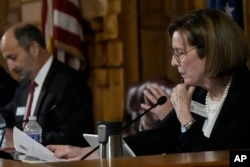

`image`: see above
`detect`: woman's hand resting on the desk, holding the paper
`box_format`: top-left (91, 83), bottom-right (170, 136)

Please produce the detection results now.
top-left (47, 145), bottom-right (98, 161)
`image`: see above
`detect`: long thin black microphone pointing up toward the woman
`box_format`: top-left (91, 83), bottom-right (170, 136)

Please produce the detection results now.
top-left (81, 96), bottom-right (167, 160)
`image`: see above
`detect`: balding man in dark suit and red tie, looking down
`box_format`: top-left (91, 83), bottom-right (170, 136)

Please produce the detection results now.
top-left (0, 23), bottom-right (94, 146)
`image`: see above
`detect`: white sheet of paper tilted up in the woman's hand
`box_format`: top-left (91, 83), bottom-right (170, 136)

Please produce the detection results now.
top-left (13, 127), bottom-right (66, 162)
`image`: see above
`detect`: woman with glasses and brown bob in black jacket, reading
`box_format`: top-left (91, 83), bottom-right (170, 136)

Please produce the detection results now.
top-left (46, 9), bottom-right (250, 157)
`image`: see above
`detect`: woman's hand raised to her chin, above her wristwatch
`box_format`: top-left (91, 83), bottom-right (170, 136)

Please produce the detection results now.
top-left (170, 83), bottom-right (195, 125)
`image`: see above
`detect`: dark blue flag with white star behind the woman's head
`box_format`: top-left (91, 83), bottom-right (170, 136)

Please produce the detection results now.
top-left (207, 0), bottom-right (244, 28)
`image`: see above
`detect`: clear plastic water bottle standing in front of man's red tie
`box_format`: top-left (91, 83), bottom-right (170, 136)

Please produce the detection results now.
top-left (23, 116), bottom-right (42, 143)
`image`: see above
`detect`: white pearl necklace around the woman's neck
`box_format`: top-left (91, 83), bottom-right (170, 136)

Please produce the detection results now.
top-left (205, 76), bottom-right (233, 118)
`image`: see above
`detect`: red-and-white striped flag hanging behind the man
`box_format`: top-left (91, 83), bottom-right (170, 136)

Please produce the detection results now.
top-left (41, 0), bottom-right (86, 69)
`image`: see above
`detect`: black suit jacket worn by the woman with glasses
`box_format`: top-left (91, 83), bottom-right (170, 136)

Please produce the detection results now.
top-left (125, 66), bottom-right (250, 155)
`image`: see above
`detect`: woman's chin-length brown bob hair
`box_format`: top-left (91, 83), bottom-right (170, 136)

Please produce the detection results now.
top-left (168, 8), bottom-right (249, 77)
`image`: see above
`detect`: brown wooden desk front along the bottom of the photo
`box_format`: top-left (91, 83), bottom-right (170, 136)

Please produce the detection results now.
top-left (36, 151), bottom-right (229, 167)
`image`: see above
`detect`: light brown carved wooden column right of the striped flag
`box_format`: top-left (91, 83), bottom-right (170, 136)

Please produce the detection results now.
top-left (83, 0), bottom-right (124, 130)
